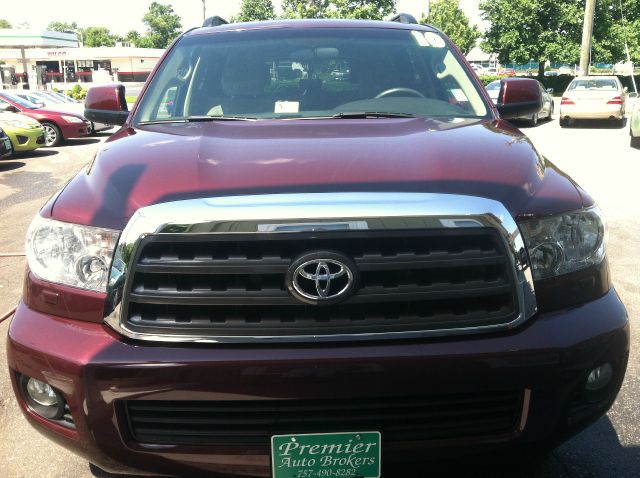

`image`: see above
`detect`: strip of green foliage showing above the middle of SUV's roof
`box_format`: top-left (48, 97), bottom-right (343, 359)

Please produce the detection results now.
top-left (282, 0), bottom-right (396, 20)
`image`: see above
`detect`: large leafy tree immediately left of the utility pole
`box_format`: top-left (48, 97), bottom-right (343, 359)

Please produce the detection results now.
top-left (480, 0), bottom-right (584, 76)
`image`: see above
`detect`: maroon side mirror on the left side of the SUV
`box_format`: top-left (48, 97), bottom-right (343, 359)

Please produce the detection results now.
top-left (84, 83), bottom-right (129, 125)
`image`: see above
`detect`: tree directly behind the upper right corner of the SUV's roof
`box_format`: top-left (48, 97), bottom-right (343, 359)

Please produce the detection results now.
top-left (420, 0), bottom-right (480, 55)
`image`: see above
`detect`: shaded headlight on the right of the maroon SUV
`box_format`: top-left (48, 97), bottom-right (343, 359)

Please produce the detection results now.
top-left (520, 208), bottom-right (604, 279)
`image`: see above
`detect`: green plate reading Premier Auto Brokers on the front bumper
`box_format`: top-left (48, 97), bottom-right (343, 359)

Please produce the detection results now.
top-left (271, 431), bottom-right (382, 478)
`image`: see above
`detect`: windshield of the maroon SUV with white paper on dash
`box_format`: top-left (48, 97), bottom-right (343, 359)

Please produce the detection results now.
top-left (135, 28), bottom-right (490, 122)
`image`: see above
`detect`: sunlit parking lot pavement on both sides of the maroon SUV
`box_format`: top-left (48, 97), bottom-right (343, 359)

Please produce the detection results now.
top-left (0, 106), bottom-right (640, 478)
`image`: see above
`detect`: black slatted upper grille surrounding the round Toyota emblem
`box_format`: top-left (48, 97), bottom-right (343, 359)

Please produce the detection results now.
top-left (122, 227), bottom-right (519, 340)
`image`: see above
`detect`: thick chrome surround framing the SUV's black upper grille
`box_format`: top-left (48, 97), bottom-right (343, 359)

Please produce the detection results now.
top-left (105, 193), bottom-right (537, 343)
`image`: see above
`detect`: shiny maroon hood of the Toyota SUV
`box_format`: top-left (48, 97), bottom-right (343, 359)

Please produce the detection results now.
top-left (50, 118), bottom-right (583, 229)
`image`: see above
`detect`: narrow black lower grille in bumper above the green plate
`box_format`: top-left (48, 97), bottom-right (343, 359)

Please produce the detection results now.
top-left (121, 391), bottom-right (523, 446)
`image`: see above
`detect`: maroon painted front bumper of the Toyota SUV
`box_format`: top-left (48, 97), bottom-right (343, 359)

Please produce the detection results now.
top-left (7, 290), bottom-right (629, 476)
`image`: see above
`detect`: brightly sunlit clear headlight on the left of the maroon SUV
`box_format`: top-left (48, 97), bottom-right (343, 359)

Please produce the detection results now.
top-left (26, 215), bottom-right (120, 292)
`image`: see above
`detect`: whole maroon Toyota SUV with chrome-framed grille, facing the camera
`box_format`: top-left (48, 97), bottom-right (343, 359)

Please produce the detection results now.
top-left (8, 16), bottom-right (629, 478)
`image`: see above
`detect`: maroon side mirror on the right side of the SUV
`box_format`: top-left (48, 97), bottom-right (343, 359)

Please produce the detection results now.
top-left (496, 78), bottom-right (542, 119)
